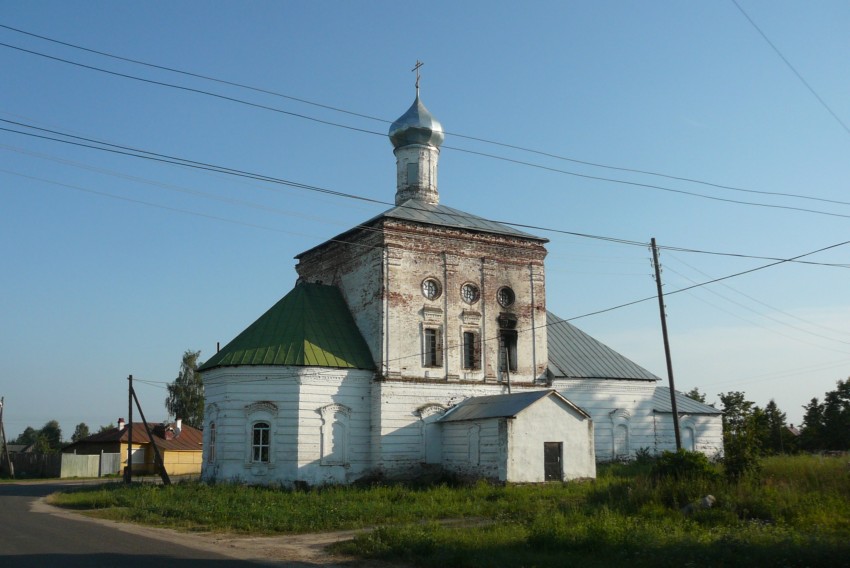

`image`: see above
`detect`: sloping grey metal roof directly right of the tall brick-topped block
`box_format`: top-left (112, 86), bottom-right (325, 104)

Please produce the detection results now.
top-left (546, 312), bottom-right (661, 381)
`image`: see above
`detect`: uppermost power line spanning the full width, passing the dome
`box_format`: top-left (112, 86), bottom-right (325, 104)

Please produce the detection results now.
top-left (0, 24), bottom-right (850, 211)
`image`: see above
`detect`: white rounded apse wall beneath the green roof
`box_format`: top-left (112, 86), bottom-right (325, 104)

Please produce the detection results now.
top-left (202, 366), bottom-right (373, 485)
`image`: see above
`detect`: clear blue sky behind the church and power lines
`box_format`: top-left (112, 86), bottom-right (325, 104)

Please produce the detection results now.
top-left (0, 0), bottom-right (850, 438)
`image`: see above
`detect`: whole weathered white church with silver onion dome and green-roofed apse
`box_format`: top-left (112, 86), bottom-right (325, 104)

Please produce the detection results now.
top-left (200, 82), bottom-right (722, 485)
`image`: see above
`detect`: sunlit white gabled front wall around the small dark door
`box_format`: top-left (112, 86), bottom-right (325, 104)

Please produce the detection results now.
top-left (507, 396), bottom-right (596, 483)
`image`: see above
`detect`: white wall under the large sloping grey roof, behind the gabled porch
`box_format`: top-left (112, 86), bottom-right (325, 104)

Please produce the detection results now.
top-left (552, 379), bottom-right (656, 462)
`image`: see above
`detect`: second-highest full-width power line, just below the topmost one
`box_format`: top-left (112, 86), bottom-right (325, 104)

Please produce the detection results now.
top-left (0, 37), bottom-right (850, 218)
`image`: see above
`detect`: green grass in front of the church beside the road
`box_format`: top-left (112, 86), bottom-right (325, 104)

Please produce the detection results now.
top-left (54, 456), bottom-right (850, 568)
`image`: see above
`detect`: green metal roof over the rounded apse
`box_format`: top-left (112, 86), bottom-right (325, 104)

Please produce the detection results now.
top-left (199, 283), bottom-right (375, 371)
